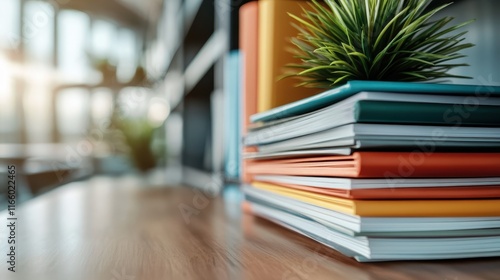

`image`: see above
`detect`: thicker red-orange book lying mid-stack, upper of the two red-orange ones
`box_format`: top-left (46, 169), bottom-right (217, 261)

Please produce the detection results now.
top-left (248, 152), bottom-right (500, 180)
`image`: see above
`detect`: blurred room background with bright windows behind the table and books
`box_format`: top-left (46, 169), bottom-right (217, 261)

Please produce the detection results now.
top-left (0, 0), bottom-right (500, 209)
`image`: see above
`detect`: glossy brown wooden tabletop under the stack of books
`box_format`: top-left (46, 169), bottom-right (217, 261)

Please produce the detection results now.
top-left (0, 177), bottom-right (500, 280)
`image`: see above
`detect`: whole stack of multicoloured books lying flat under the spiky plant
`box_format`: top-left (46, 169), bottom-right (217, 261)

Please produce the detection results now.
top-left (244, 81), bottom-right (500, 261)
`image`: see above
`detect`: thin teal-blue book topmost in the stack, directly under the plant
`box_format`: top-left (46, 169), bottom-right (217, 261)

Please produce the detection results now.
top-left (251, 81), bottom-right (500, 122)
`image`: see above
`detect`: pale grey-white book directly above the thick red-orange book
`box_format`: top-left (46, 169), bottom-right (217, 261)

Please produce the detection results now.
top-left (259, 124), bottom-right (500, 153)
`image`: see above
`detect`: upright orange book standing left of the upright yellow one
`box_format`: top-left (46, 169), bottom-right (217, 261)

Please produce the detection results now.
top-left (239, 1), bottom-right (259, 182)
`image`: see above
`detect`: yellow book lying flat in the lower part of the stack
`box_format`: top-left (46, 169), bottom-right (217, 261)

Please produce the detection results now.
top-left (252, 182), bottom-right (500, 217)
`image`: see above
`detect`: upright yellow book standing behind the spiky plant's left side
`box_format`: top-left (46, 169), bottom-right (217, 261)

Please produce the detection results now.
top-left (258, 0), bottom-right (322, 112)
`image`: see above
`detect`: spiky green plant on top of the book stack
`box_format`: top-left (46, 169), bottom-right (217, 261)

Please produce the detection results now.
top-left (286, 0), bottom-right (473, 88)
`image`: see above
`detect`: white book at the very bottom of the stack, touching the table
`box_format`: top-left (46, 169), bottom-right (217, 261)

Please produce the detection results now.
top-left (252, 202), bottom-right (500, 262)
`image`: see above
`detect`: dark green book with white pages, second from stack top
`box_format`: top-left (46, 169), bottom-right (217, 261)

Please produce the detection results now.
top-left (245, 92), bottom-right (500, 148)
